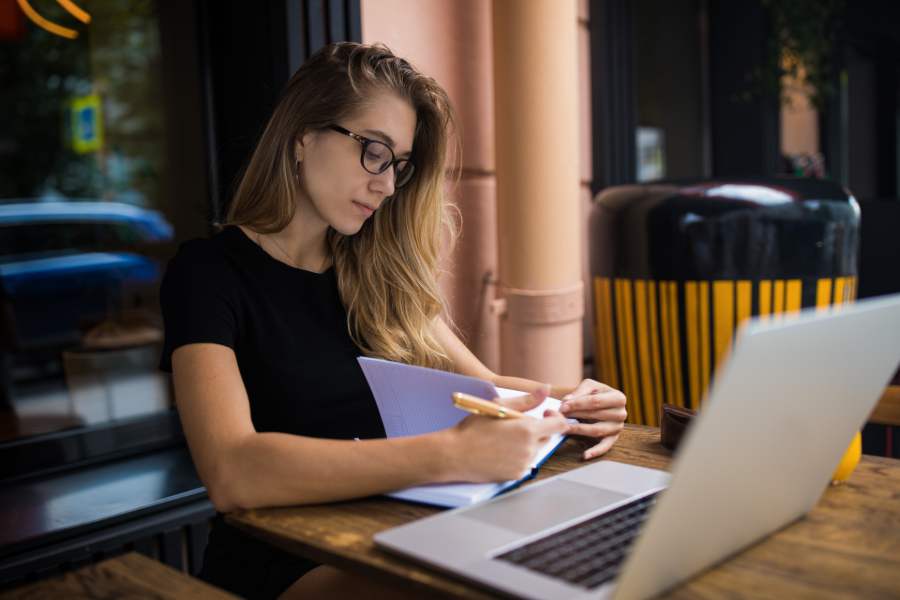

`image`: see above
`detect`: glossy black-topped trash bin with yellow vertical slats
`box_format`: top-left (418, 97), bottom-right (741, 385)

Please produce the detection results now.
top-left (589, 178), bottom-right (860, 426)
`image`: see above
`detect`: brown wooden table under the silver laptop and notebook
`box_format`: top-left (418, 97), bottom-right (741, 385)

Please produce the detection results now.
top-left (227, 425), bottom-right (900, 598)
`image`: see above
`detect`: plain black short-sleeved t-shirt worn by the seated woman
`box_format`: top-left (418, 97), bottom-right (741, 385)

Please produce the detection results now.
top-left (160, 227), bottom-right (385, 439)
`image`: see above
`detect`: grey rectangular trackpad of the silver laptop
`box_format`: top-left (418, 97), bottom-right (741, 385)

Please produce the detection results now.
top-left (459, 479), bottom-right (629, 535)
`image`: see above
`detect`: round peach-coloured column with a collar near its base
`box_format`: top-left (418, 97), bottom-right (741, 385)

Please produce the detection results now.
top-left (493, 0), bottom-right (584, 384)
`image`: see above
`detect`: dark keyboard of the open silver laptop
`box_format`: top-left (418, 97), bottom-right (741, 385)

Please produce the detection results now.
top-left (495, 492), bottom-right (659, 589)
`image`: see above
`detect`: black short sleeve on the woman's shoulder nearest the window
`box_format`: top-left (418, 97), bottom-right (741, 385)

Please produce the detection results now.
top-left (159, 240), bottom-right (239, 372)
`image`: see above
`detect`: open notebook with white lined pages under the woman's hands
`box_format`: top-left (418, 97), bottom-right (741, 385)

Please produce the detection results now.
top-left (357, 357), bottom-right (565, 508)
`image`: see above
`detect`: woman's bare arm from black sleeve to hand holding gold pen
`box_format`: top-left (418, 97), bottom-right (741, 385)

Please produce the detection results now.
top-left (172, 344), bottom-right (566, 512)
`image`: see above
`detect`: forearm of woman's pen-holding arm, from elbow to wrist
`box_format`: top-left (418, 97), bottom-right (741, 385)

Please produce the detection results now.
top-left (208, 431), bottom-right (453, 512)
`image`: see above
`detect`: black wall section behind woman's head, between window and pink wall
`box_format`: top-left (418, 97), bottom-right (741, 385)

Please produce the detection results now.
top-left (200, 0), bottom-right (361, 219)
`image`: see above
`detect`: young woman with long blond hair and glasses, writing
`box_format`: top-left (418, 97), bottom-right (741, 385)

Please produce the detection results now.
top-left (160, 43), bottom-right (625, 597)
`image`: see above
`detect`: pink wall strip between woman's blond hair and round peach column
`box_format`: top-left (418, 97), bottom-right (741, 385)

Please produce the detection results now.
top-left (361, 0), bottom-right (500, 370)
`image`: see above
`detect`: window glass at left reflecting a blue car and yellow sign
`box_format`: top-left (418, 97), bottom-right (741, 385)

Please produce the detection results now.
top-left (0, 0), bottom-right (193, 443)
